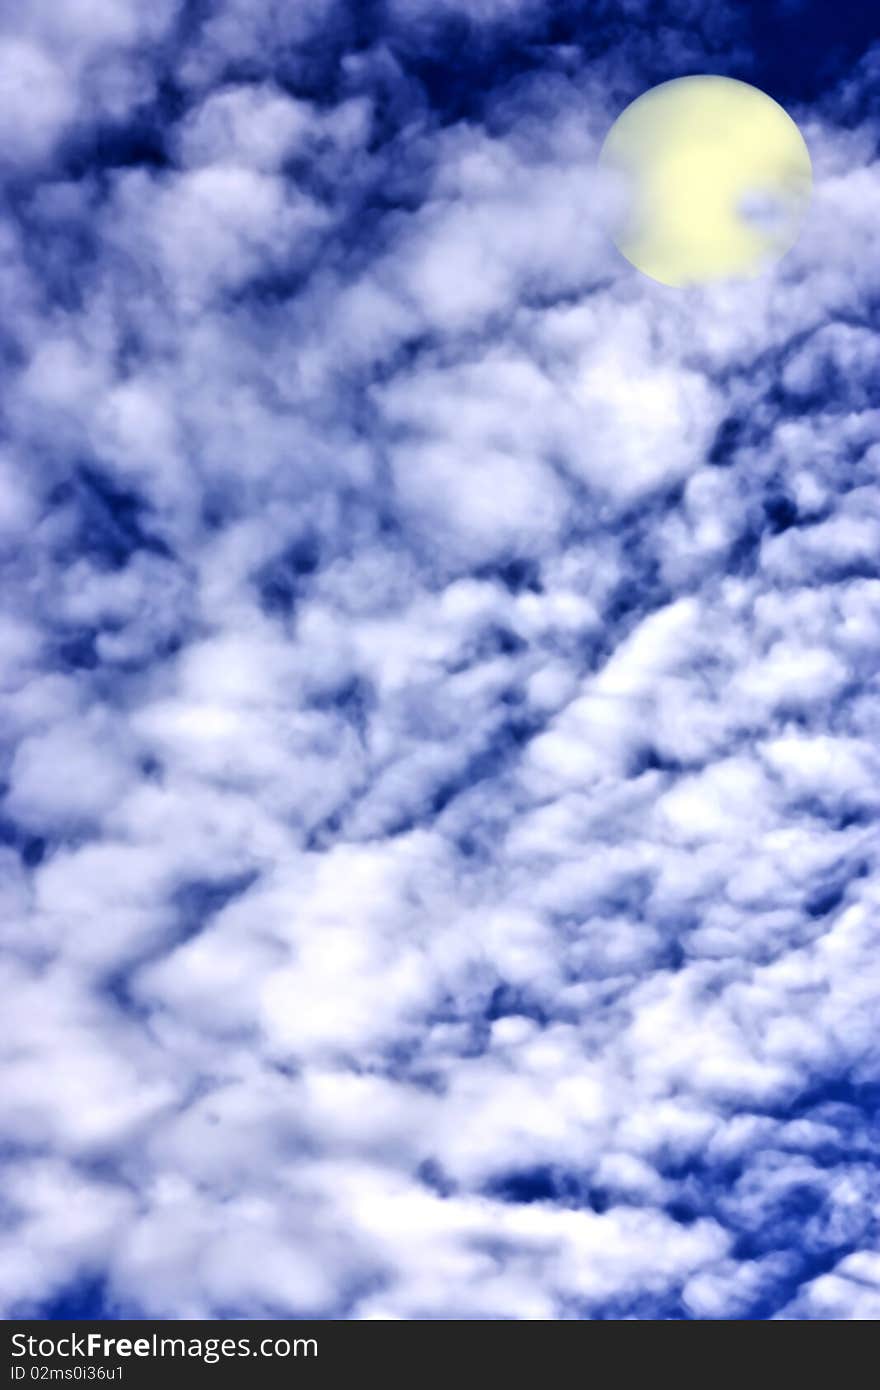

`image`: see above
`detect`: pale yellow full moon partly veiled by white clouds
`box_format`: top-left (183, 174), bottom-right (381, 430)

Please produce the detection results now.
top-left (599, 76), bottom-right (813, 285)
